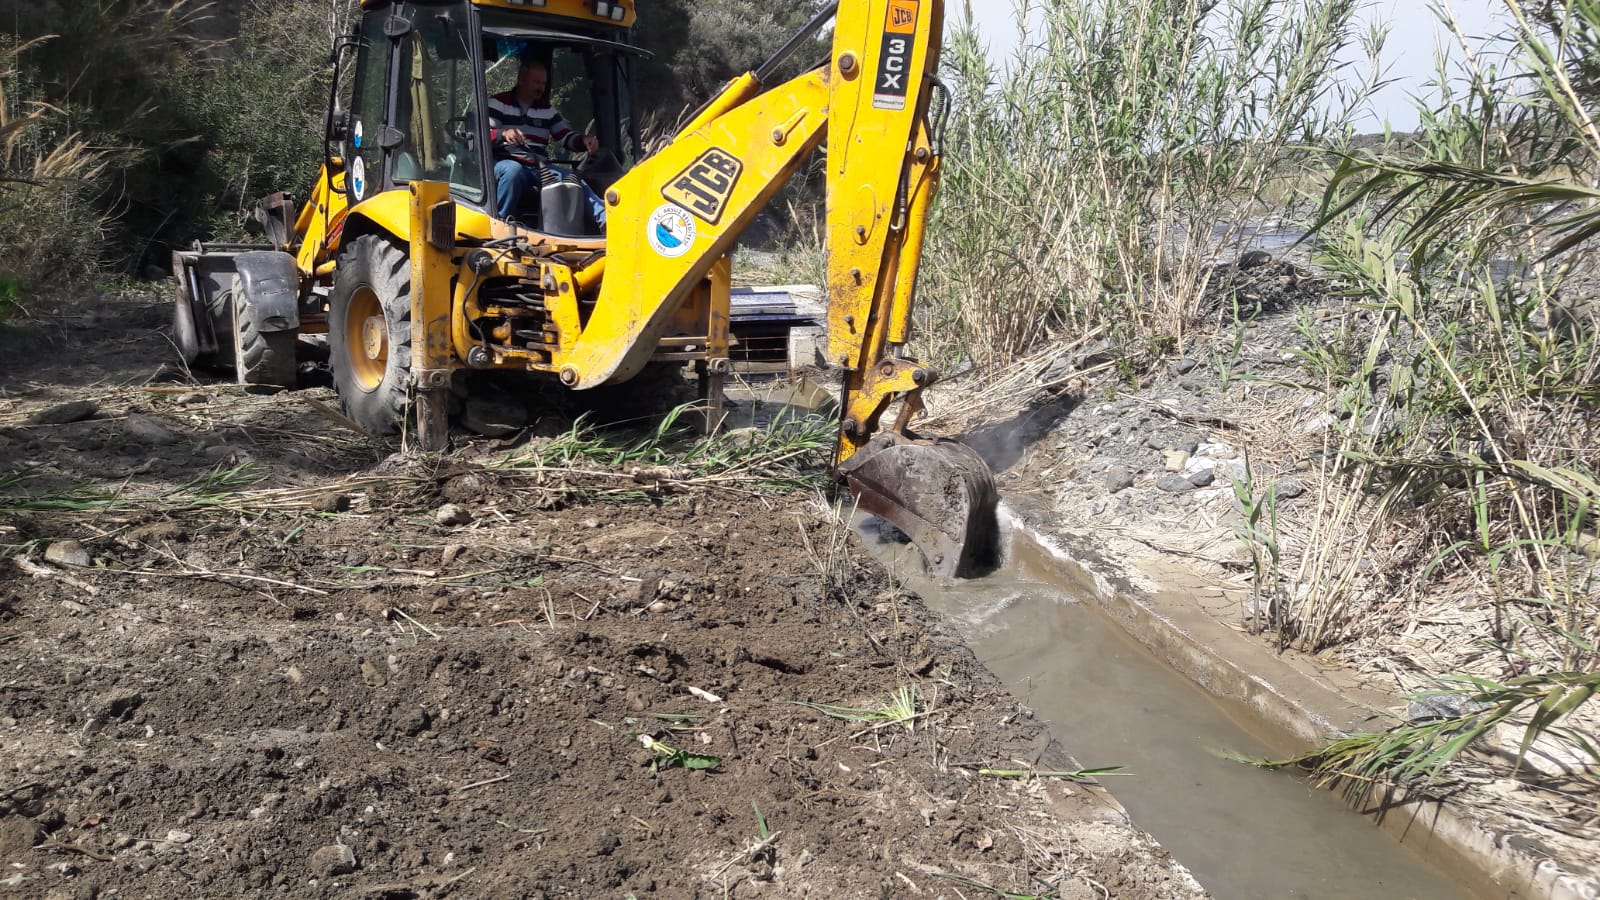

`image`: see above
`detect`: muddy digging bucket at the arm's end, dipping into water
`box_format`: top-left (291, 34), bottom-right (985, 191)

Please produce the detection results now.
top-left (838, 431), bottom-right (1000, 578)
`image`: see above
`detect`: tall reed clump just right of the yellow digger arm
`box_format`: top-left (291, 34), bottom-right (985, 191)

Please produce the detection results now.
top-left (922, 0), bottom-right (1381, 364)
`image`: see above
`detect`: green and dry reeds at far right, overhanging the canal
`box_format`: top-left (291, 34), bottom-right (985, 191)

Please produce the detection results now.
top-left (1280, 0), bottom-right (1600, 780)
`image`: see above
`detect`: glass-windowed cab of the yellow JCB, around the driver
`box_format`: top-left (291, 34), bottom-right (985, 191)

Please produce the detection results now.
top-left (338, 0), bottom-right (640, 235)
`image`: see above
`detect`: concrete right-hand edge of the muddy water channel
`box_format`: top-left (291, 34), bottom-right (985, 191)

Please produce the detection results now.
top-left (1000, 504), bottom-right (1600, 900)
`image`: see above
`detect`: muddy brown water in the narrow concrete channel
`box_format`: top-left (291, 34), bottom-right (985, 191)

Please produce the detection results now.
top-left (866, 533), bottom-right (1486, 900)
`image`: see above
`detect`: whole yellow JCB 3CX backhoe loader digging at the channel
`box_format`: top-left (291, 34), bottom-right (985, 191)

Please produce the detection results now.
top-left (174, 0), bottom-right (997, 575)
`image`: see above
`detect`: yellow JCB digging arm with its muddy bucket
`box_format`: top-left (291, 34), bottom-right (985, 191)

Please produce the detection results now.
top-left (560, 0), bottom-right (997, 575)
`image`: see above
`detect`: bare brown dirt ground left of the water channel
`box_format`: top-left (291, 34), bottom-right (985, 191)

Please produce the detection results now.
top-left (0, 293), bottom-right (1202, 898)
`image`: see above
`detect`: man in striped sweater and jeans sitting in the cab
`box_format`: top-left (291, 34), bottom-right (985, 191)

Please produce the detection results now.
top-left (490, 59), bottom-right (605, 231)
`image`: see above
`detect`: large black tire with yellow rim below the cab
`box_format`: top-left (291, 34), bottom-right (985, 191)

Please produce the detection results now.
top-left (328, 235), bottom-right (411, 434)
